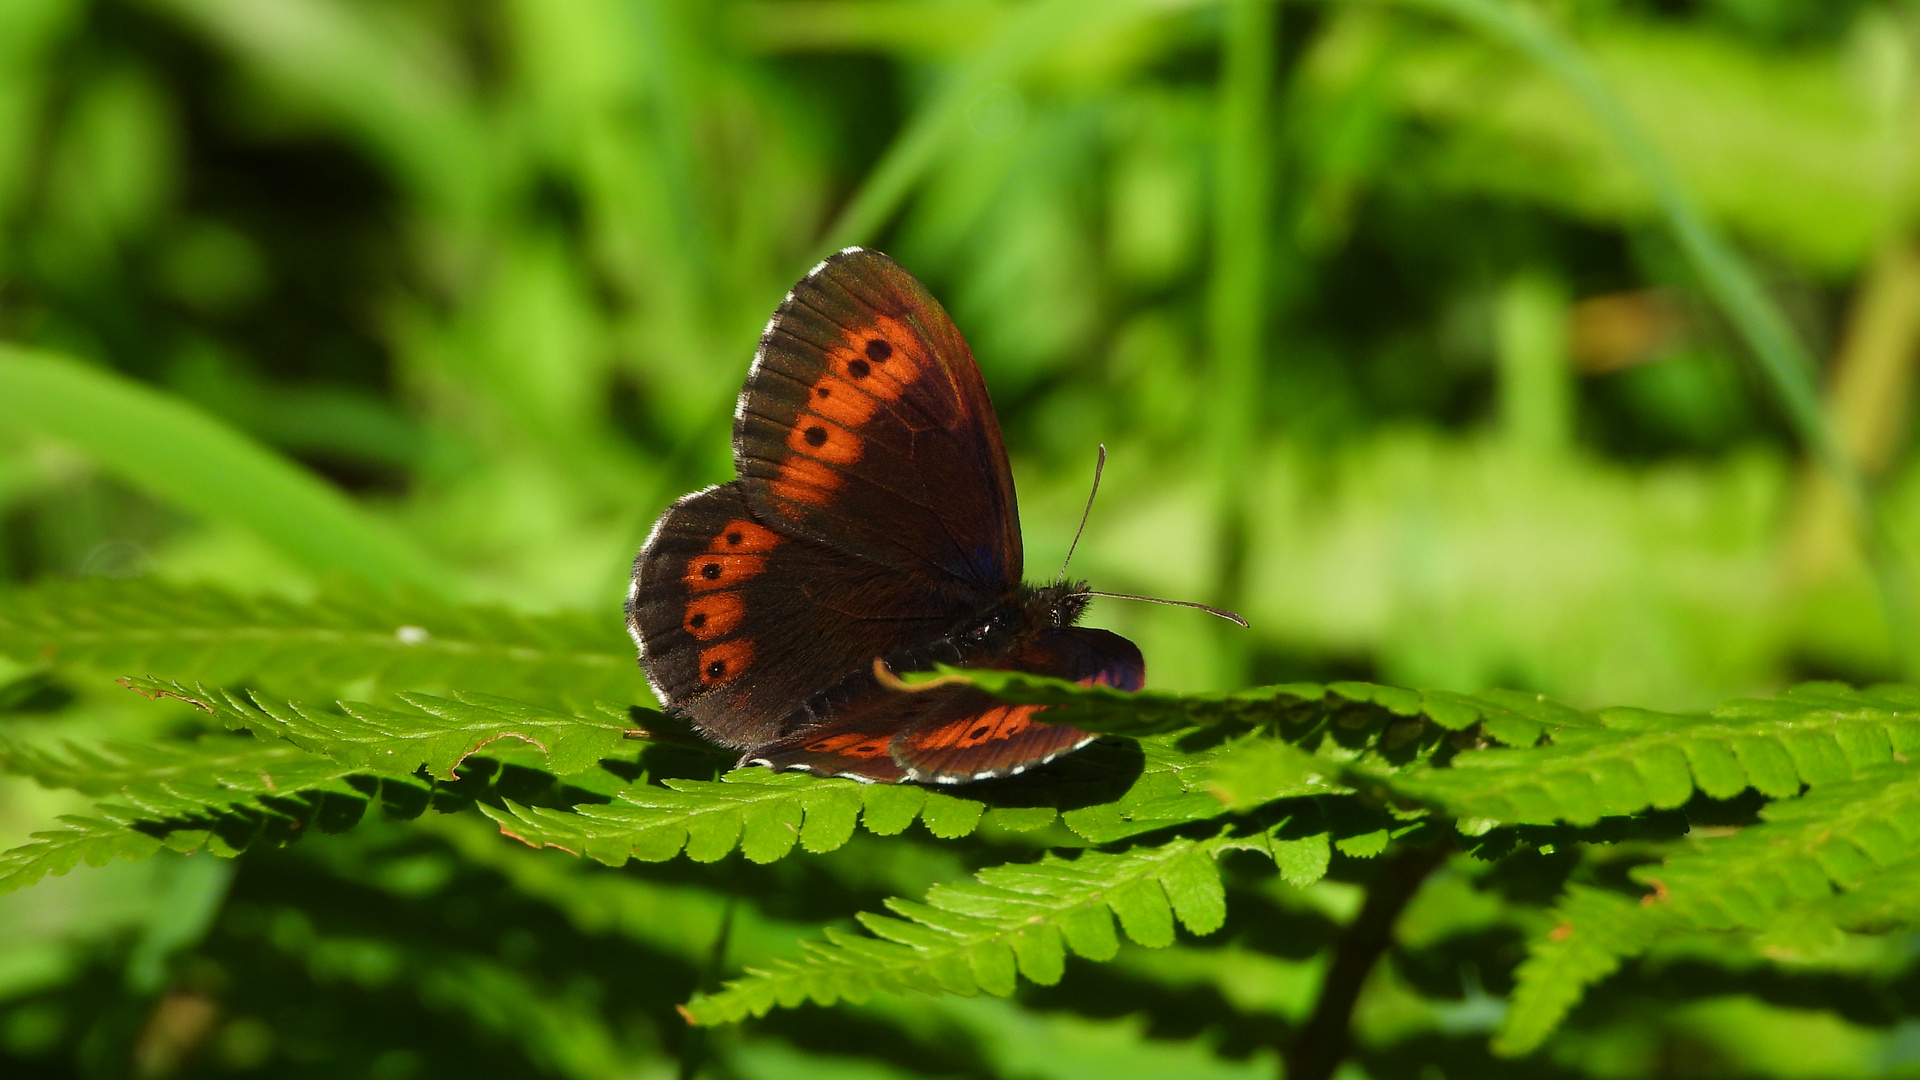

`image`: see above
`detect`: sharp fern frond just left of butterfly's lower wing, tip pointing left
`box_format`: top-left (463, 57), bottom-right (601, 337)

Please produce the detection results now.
top-left (121, 678), bottom-right (636, 780)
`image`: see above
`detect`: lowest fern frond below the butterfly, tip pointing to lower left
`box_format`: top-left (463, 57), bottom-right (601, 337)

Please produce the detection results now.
top-left (685, 818), bottom-right (1328, 1024)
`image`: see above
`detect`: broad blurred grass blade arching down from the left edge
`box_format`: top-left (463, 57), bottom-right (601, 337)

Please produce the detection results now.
top-left (0, 344), bottom-right (453, 592)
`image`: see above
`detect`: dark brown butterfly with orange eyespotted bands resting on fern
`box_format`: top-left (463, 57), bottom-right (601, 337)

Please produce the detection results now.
top-left (626, 248), bottom-right (1198, 784)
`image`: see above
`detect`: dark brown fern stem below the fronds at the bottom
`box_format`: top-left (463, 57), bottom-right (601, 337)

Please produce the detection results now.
top-left (1286, 844), bottom-right (1450, 1080)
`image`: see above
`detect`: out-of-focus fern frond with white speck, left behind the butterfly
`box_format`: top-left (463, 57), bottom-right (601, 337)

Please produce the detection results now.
top-left (0, 578), bottom-right (653, 701)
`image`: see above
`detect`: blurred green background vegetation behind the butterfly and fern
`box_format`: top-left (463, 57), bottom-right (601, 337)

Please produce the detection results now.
top-left (0, 0), bottom-right (1920, 1078)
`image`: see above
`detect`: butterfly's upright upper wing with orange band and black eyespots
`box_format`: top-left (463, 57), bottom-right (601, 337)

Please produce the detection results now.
top-left (733, 248), bottom-right (1021, 588)
